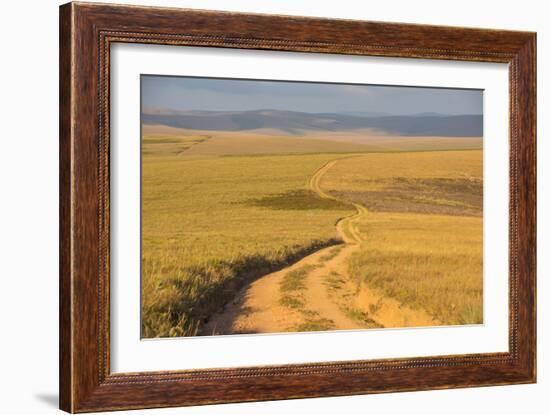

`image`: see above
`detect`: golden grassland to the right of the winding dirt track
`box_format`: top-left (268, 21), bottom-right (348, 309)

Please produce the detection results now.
top-left (322, 150), bottom-right (483, 324)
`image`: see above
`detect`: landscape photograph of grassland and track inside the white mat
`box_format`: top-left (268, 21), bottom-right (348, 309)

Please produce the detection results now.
top-left (140, 74), bottom-right (483, 339)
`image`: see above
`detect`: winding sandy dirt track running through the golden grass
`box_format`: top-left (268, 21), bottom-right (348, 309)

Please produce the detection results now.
top-left (199, 160), bottom-right (438, 335)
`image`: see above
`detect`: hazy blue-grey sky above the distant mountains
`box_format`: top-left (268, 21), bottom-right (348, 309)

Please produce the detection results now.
top-left (141, 75), bottom-right (483, 115)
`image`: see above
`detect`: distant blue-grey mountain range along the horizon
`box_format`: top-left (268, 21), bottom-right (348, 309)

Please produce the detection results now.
top-left (142, 108), bottom-right (483, 137)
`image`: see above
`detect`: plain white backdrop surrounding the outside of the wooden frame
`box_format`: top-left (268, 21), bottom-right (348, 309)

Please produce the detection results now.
top-left (0, 0), bottom-right (550, 415)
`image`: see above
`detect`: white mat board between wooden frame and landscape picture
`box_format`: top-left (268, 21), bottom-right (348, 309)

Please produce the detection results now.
top-left (110, 44), bottom-right (509, 372)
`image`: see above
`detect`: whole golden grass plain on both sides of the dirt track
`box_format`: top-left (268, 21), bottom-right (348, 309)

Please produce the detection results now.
top-left (142, 128), bottom-right (483, 338)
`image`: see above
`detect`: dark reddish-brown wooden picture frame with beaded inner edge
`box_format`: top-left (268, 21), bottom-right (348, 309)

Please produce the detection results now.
top-left (60, 3), bottom-right (536, 412)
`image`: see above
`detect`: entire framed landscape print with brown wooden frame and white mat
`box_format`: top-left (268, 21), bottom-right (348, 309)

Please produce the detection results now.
top-left (60, 3), bottom-right (536, 412)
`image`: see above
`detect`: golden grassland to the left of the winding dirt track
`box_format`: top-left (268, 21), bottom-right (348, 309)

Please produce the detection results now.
top-left (142, 138), bottom-right (353, 337)
